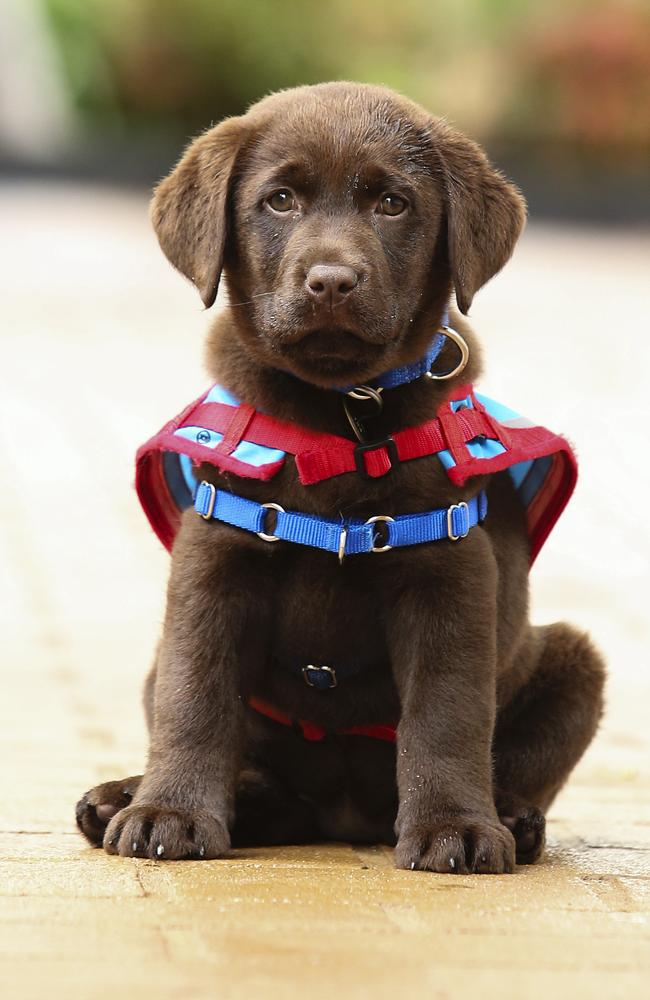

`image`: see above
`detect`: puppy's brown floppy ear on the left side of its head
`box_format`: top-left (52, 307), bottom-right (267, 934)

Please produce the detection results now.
top-left (150, 118), bottom-right (245, 308)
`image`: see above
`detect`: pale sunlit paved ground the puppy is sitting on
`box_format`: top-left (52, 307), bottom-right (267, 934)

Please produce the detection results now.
top-left (0, 186), bottom-right (650, 1000)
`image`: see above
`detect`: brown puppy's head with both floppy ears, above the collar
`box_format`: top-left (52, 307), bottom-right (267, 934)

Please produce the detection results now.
top-left (152, 83), bottom-right (524, 386)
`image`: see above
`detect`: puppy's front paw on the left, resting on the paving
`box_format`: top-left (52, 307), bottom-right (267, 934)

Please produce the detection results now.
top-left (104, 803), bottom-right (230, 861)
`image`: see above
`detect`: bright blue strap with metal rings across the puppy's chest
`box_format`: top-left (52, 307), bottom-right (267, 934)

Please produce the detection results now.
top-left (194, 481), bottom-right (487, 560)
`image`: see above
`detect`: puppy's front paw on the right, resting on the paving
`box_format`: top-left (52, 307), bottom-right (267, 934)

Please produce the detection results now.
top-left (395, 819), bottom-right (515, 875)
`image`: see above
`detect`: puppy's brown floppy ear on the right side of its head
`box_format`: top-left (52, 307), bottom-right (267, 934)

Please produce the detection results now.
top-left (432, 122), bottom-right (526, 314)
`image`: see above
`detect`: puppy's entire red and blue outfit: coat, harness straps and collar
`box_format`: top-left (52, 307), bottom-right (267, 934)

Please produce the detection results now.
top-left (136, 327), bottom-right (577, 740)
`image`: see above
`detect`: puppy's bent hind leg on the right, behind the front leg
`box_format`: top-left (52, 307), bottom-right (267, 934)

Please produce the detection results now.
top-left (493, 623), bottom-right (605, 864)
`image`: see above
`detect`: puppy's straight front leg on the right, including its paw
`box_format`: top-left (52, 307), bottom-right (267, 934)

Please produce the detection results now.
top-left (389, 553), bottom-right (515, 873)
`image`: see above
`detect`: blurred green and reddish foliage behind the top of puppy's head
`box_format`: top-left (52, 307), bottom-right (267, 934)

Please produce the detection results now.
top-left (40, 0), bottom-right (650, 166)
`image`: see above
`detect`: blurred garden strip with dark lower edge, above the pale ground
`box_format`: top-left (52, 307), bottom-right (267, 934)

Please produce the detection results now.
top-left (0, 0), bottom-right (650, 223)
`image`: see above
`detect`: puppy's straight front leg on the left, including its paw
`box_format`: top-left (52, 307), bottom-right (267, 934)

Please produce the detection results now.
top-left (104, 512), bottom-right (269, 859)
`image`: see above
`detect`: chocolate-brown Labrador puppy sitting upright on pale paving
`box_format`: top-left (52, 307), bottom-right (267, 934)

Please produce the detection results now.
top-left (77, 83), bottom-right (604, 872)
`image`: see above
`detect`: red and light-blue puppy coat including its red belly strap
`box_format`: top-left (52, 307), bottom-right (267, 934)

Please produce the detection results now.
top-left (136, 386), bottom-right (577, 741)
